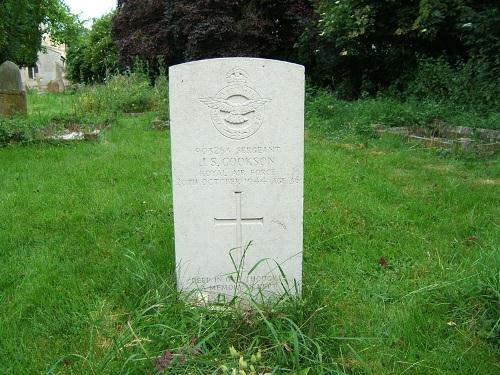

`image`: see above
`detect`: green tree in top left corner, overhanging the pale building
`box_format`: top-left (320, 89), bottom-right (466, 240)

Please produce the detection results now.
top-left (0, 0), bottom-right (83, 65)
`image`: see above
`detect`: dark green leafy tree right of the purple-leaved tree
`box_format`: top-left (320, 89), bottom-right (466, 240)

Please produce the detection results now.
top-left (301, 0), bottom-right (500, 98)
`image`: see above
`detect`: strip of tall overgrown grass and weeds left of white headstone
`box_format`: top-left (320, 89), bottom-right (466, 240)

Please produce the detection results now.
top-left (0, 70), bottom-right (168, 147)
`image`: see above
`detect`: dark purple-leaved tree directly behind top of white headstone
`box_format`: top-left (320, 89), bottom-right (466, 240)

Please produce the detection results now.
top-left (113, 0), bottom-right (312, 69)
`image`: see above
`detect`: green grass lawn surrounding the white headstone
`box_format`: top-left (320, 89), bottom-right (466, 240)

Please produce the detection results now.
top-left (0, 86), bottom-right (500, 375)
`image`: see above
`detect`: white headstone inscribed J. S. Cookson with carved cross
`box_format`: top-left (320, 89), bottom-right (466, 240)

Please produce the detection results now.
top-left (169, 58), bottom-right (304, 301)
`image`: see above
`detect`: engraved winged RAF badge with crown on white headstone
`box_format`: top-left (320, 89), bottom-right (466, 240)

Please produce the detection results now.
top-left (200, 68), bottom-right (271, 139)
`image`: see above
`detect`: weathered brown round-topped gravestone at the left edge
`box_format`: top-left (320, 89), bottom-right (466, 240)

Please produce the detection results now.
top-left (0, 61), bottom-right (27, 116)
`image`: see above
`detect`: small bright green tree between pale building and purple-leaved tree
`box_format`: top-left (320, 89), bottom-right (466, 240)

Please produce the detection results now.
top-left (67, 13), bottom-right (119, 83)
